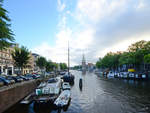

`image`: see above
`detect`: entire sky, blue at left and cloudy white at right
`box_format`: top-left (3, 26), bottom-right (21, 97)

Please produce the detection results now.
top-left (4, 0), bottom-right (150, 66)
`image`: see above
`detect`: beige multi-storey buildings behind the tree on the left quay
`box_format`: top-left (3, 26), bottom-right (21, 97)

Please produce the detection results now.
top-left (0, 44), bottom-right (40, 75)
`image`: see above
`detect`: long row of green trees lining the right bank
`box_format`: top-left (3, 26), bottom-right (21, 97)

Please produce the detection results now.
top-left (96, 40), bottom-right (150, 69)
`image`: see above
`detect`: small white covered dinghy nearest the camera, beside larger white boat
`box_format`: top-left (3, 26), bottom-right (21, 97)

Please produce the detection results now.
top-left (54, 90), bottom-right (71, 108)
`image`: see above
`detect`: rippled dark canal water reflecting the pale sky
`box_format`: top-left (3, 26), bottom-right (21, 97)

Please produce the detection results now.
top-left (5, 71), bottom-right (150, 113)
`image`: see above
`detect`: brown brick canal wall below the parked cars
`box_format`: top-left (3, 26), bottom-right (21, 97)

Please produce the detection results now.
top-left (0, 80), bottom-right (40, 113)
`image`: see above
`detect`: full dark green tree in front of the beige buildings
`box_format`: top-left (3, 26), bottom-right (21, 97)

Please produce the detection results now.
top-left (12, 46), bottom-right (30, 74)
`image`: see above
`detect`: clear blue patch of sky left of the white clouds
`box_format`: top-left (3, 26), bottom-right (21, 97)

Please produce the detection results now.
top-left (4, 0), bottom-right (59, 48)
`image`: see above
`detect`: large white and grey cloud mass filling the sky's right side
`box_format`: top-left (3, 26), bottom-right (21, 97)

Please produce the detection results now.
top-left (33, 0), bottom-right (150, 65)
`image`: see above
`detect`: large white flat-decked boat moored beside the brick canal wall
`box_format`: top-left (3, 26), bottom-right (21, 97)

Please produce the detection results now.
top-left (34, 78), bottom-right (62, 104)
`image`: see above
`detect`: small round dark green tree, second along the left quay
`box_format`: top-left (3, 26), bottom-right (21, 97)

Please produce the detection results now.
top-left (36, 57), bottom-right (47, 70)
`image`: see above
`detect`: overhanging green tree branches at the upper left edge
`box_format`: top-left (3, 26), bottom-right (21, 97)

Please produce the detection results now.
top-left (0, 0), bottom-right (14, 49)
